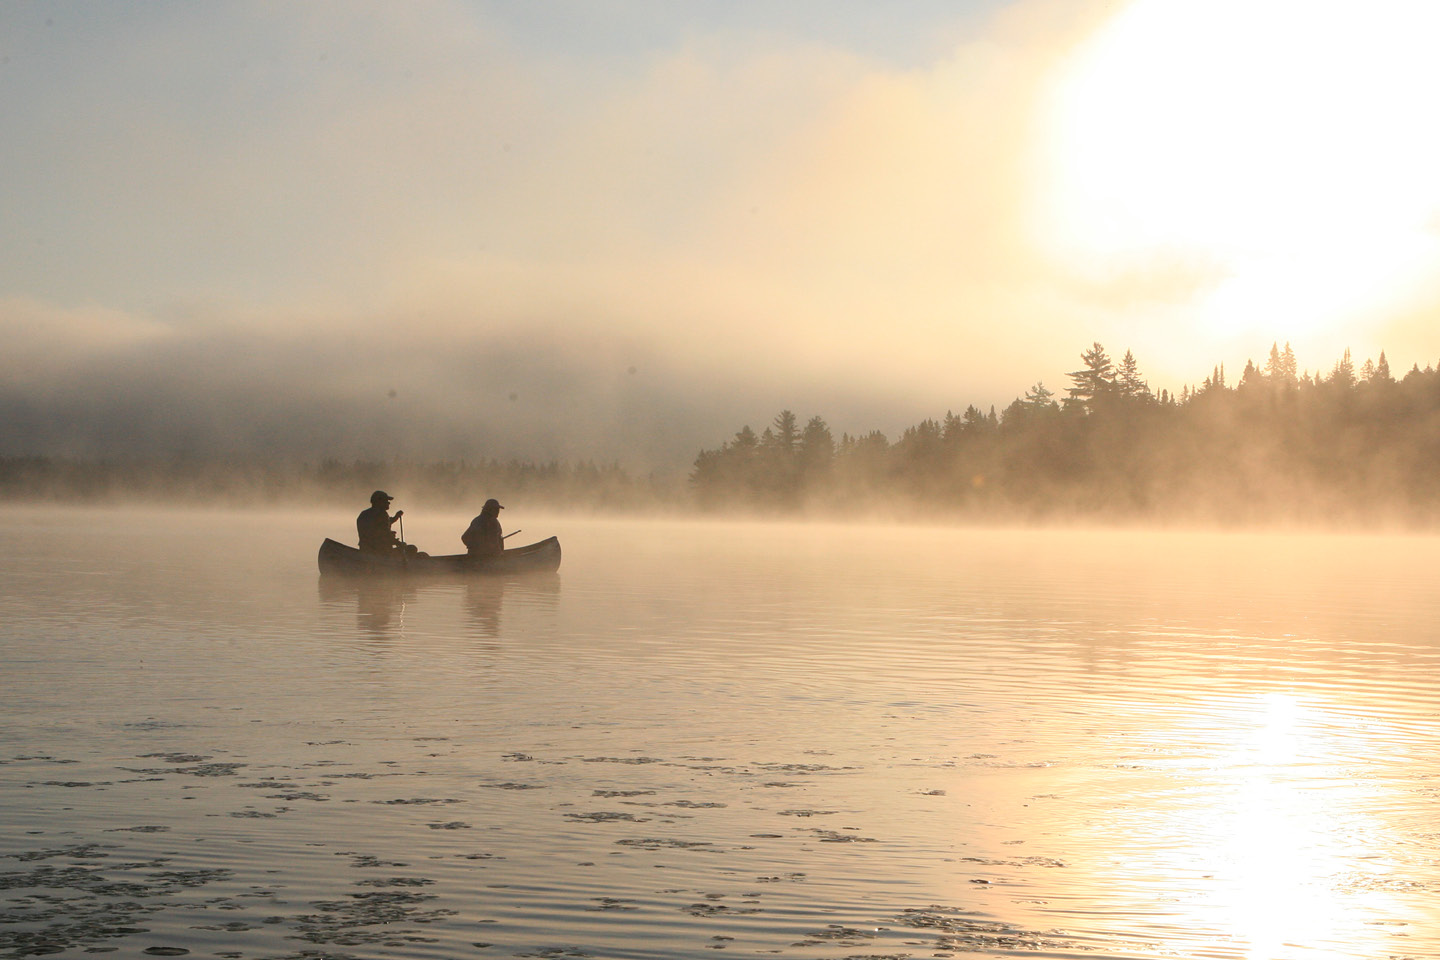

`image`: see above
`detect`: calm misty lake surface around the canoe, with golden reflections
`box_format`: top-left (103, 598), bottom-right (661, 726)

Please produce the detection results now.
top-left (0, 504), bottom-right (1440, 960)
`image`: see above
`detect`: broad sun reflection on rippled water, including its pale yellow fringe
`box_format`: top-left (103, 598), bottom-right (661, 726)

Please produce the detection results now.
top-left (1074, 689), bottom-right (1431, 960)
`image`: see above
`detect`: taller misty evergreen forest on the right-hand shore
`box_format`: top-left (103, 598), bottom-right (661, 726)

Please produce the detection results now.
top-left (690, 343), bottom-right (1440, 524)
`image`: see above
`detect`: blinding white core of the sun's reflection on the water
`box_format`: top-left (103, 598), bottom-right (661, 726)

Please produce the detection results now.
top-left (1157, 691), bottom-right (1407, 960)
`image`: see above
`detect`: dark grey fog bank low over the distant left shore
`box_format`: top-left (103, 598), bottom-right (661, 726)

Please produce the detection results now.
top-left (0, 297), bottom-right (933, 471)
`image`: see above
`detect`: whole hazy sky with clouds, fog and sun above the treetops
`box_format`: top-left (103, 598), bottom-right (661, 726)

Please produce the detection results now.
top-left (0, 0), bottom-right (1440, 469)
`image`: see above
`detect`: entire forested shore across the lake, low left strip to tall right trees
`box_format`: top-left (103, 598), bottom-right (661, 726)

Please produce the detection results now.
top-left (8, 343), bottom-right (1440, 527)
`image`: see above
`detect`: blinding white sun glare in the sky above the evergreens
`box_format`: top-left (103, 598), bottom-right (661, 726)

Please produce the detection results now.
top-left (1037, 0), bottom-right (1440, 338)
